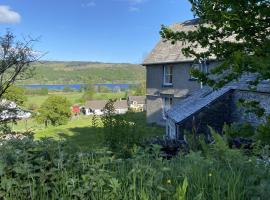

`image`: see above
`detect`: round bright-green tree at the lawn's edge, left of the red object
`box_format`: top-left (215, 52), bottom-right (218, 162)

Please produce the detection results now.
top-left (37, 96), bottom-right (71, 127)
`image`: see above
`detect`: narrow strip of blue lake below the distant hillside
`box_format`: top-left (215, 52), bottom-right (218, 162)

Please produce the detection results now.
top-left (22, 83), bottom-right (131, 90)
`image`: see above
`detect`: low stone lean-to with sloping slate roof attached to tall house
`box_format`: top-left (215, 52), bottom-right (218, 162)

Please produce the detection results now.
top-left (166, 76), bottom-right (270, 139)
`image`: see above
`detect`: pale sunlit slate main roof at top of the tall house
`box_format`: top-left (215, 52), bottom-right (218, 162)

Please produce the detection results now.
top-left (143, 19), bottom-right (203, 65)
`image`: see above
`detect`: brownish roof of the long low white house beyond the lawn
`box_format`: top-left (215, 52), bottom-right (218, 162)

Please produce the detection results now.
top-left (85, 100), bottom-right (128, 110)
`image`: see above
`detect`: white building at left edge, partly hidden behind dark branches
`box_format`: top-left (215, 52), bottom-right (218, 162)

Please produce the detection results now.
top-left (0, 99), bottom-right (32, 121)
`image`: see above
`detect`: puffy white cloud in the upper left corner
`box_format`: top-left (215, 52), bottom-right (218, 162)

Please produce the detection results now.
top-left (0, 5), bottom-right (21, 24)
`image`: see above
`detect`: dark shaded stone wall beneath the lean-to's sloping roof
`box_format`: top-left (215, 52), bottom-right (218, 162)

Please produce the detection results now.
top-left (177, 90), bottom-right (270, 139)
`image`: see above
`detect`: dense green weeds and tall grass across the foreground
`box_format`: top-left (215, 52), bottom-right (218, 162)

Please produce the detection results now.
top-left (0, 139), bottom-right (270, 200)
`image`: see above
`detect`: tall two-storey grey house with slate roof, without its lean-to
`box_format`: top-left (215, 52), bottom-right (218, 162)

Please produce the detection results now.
top-left (143, 19), bottom-right (215, 126)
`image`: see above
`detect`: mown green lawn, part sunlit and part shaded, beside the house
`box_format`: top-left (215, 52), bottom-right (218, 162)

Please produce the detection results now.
top-left (13, 113), bottom-right (164, 149)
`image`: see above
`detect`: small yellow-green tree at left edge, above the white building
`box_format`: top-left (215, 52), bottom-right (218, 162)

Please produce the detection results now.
top-left (2, 85), bottom-right (27, 106)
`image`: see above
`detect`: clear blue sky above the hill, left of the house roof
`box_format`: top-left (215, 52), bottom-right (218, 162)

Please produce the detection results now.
top-left (0, 0), bottom-right (193, 63)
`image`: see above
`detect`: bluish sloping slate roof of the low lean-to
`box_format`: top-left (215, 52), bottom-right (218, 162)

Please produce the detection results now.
top-left (166, 76), bottom-right (270, 123)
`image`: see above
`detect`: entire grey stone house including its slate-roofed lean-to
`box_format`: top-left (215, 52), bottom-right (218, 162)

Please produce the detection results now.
top-left (143, 20), bottom-right (270, 139)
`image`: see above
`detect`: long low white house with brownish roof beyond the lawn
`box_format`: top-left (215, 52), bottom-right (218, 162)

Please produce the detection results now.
top-left (85, 100), bottom-right (128, 115)
